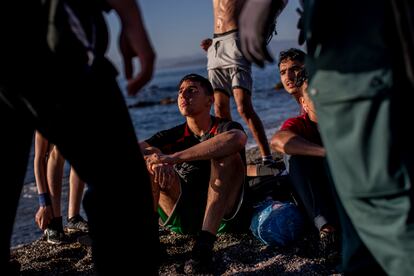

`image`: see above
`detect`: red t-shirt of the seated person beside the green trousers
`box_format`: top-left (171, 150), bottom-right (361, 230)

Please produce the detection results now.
top-left (280, 113), bottom-right (322, 146)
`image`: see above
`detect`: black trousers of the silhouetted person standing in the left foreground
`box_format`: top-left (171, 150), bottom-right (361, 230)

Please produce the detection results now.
top-left (0, 63), bottom-right (158, 274)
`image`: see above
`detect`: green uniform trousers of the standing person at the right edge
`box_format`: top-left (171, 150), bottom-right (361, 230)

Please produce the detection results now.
top-left (310, 69), bottom-right (414, 275)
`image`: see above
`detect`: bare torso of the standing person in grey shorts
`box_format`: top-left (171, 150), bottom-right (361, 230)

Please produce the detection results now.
top-left (213, 0), bottom-right (245, 34)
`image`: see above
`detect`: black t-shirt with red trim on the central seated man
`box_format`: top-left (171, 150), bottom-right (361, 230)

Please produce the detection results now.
top-left (145, 116), bottom-right (246, 184)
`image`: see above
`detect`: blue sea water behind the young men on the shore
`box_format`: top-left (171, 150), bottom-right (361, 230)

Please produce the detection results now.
top-left (25, 64), bottom-right (299, 183)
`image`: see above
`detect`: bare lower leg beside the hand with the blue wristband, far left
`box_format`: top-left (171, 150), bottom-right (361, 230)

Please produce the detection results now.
top-left (47, 146), bottom-right (65, 217)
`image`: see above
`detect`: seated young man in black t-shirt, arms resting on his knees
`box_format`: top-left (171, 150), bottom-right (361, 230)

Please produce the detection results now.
top-left (140, 74), bottom-right (247, 266)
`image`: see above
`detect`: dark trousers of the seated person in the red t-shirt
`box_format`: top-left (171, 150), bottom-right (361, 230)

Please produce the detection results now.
top-left (288, 155), bottom-right (337, 230)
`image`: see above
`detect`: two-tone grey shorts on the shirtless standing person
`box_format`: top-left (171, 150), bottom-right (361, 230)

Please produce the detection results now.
top-left (207, 32), bottom-right (253, 96)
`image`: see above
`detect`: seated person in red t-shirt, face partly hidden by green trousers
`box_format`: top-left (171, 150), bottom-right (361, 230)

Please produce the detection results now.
top-left (271, 71), bottom-right (337, 254)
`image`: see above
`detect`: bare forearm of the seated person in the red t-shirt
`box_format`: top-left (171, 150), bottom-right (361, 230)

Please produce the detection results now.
top-left (271, 130), bottom-right (326, 157)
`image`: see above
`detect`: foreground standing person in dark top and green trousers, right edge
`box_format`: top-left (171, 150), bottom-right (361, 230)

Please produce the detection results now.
top-left (304, 0), bottom-right (414, 275)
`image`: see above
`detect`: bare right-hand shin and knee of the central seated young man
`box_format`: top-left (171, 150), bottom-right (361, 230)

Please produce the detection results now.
top-left (202, 153), bottom-right (245, 235)
